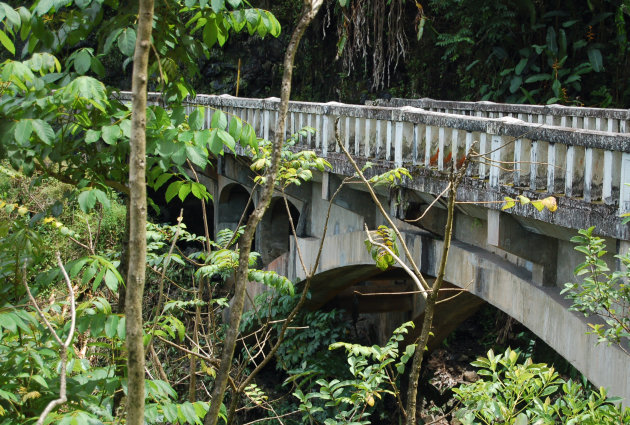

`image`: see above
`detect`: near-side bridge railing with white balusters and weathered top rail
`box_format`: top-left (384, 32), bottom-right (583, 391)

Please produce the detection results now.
top-left (146, 95), bottom-right (630, 212)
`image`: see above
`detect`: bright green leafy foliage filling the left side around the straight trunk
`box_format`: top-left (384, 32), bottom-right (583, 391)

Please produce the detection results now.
top-left (0, 0), bottom-right (286, 424)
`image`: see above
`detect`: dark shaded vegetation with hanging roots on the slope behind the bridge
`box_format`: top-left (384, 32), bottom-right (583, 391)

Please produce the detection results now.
top-left (212, 0), bottom-right (630, 108)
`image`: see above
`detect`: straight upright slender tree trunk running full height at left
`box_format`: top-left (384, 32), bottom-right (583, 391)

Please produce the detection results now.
top-left (125, 0), bottom-right (153, 425)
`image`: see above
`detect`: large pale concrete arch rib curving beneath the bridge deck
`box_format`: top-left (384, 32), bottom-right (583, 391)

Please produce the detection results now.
top-left (287, 232), bottom-right (630, 400)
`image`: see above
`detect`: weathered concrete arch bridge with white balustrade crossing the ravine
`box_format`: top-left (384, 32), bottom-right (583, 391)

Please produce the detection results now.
top-left (144, 95), bottom-right (630, 402)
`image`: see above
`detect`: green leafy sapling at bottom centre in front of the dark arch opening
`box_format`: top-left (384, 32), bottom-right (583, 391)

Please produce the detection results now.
top-left (293, 322), bottom-right (416, 425)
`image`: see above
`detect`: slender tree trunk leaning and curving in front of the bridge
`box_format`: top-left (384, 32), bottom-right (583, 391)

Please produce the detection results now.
top-left (205, 0), bottom-right (323, 425)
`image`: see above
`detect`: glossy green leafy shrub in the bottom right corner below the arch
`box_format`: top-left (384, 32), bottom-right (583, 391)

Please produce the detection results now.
top-left (453, 348), bottom-right (630, 425)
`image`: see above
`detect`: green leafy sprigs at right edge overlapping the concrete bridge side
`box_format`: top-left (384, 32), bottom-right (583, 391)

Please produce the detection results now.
top-left (562, 227), bottom-right (630, 352)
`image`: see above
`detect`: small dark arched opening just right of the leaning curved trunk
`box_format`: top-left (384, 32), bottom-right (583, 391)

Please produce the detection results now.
top-left (259, 197), bottom-right (300, 264)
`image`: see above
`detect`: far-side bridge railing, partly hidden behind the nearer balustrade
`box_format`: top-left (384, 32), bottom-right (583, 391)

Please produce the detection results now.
top-left (369, 98), bottom-right (630, 133)
